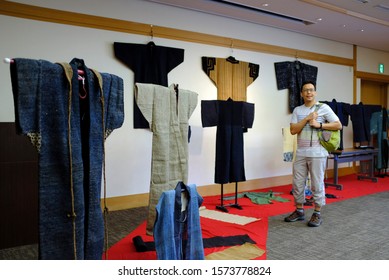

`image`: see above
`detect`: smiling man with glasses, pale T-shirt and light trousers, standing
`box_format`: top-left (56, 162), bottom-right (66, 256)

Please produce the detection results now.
top-left (284, 81), bottom-right (342, 227)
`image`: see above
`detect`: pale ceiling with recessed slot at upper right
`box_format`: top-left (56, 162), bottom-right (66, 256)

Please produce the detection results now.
top-left (144, 0), bottom-right (389, 52)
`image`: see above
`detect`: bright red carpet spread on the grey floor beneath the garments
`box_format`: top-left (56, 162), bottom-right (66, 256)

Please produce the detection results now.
top-left (104, 175), bottom-right (389, 260)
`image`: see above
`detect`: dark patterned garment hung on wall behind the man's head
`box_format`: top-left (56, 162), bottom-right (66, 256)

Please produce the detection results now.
top-left (274, 60), bottom-right (318, 113)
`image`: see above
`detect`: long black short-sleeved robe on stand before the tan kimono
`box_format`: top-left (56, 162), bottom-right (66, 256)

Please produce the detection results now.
top-left (201, 98), bottom-right (254, 184)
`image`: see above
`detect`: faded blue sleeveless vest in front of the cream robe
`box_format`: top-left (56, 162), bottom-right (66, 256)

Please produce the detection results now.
top-left (154, 182), bottom-right (204, 260)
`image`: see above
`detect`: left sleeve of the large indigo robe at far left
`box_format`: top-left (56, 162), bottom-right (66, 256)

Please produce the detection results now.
top-left (10, 58), bottom-right (69, 152)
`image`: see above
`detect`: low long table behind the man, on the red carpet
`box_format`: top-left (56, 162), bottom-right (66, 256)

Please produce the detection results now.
top-left (325, 148), bottom-right (378, 190)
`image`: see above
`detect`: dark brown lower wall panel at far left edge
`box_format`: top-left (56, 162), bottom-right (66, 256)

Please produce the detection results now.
top-left (0, 123), bottom-right (38, 249)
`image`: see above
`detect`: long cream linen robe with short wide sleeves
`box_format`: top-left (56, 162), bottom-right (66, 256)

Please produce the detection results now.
top-left (135, 83), bottom-right (197, 235)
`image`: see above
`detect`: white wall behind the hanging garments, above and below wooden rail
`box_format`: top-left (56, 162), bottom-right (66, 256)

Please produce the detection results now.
top-left (0, 0), bottom-right (384, 197)
